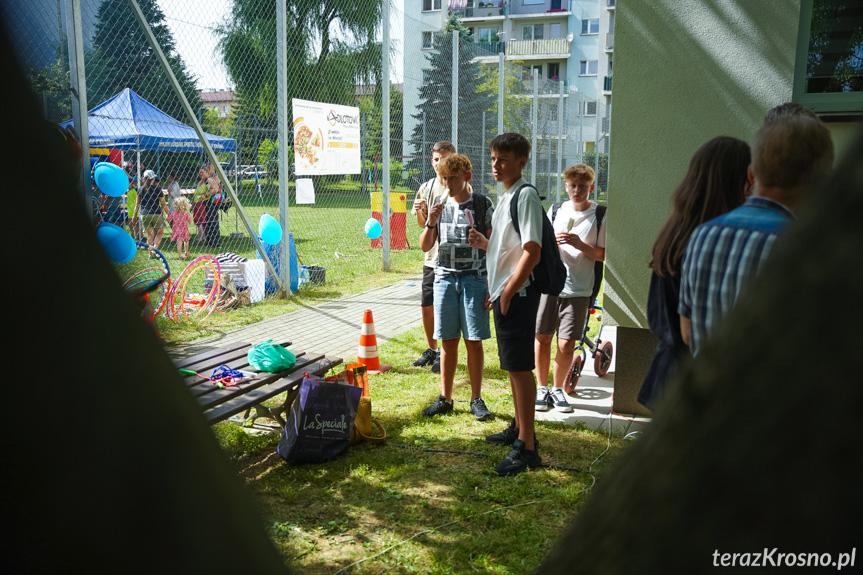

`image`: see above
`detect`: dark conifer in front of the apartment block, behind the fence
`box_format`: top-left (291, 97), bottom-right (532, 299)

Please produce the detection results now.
top-left (411, 14), bottom-right (494, 164)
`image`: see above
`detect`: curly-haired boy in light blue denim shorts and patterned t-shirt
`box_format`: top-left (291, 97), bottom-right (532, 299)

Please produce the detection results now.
top-left (420, 154), bottom-right (494, 420)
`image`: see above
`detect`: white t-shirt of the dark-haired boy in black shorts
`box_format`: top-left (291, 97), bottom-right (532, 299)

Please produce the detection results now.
top-left (485, 178), bottom-right (545, 301)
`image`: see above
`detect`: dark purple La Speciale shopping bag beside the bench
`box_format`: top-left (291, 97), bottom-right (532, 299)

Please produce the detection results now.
top-left (276, 374), bottom-right (362, 463)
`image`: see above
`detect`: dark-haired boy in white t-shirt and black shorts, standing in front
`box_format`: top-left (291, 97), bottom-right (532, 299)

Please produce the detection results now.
top-left (469, 133), bottom-right (545, 475)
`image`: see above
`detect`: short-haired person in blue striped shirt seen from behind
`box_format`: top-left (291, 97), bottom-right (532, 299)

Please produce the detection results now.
top-left (677, 104), bottom-right (833, 356)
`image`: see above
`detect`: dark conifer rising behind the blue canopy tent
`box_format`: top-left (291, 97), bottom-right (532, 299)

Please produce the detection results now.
top-left (87, 0), bottom-right (201, 118)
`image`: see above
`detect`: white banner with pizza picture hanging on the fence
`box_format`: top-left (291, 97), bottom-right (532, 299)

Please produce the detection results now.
top-left (292, 98), bottom-right (361, 176)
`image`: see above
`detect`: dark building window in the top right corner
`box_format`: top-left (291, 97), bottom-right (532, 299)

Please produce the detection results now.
top-left (793, 0), bottom-right (863, 114)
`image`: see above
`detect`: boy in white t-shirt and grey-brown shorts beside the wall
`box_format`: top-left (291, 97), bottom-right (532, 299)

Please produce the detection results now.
top-left (534, 164), bottom-right (605, 413)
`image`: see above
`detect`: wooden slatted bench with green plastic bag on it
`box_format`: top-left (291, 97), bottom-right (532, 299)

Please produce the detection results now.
top-left (174, 342), bottom-right (342, 427)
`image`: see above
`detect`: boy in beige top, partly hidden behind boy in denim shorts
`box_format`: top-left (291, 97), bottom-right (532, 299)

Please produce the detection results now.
top-left (411, 140), bottom-right (472, 373)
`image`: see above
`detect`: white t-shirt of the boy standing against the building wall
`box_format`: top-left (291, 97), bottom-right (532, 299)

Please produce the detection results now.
top-left (548, 202), bottom-right (605, 297)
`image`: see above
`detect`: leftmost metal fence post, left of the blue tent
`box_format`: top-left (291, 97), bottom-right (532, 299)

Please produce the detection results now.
top-left (65, 0), bottom-right (93, 217)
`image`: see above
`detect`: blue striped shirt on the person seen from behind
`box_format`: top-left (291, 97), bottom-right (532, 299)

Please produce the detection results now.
top-left (677, 198), bottom-right (794, 356)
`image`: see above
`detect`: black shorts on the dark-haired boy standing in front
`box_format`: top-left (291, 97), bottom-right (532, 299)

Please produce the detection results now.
top-left (492, 285), bottom-right (540, 371)
